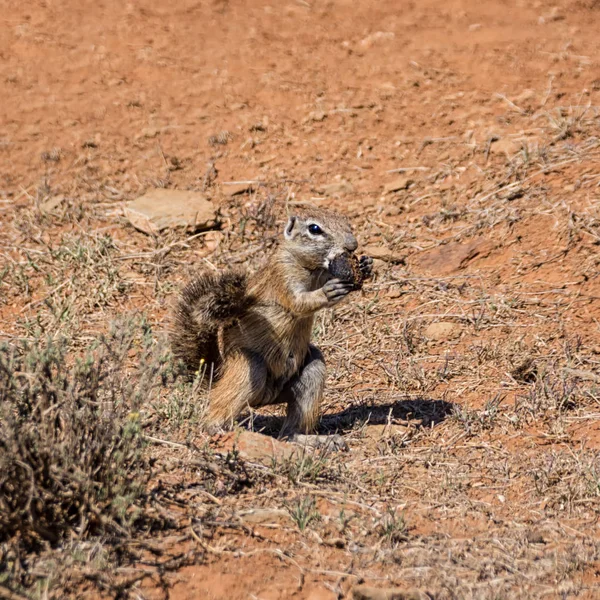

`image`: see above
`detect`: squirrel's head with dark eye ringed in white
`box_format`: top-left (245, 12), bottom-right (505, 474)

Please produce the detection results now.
top-left (283, 207), bottom-right (358, 271)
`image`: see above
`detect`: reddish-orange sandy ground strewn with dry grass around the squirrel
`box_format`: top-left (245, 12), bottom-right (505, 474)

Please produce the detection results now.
top-left (0, 0), bottom-right (600, 600)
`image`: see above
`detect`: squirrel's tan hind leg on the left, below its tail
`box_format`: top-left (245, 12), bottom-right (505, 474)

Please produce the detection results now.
top-left (206, 350), bottom-right (267, 430)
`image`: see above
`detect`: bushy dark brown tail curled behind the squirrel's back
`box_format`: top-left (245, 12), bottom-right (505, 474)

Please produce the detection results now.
top-left (170, 271), bottom-right (251, 373)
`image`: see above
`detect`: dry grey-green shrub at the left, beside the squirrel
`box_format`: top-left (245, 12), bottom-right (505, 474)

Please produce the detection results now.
top-left (0, 319), bottom-right (169, 556)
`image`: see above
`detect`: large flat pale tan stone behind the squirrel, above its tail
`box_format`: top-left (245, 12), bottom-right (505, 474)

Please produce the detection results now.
top-left (125, 188), bottom-right (217, 235)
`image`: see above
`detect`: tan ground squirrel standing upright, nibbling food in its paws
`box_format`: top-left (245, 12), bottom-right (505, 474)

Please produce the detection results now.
top-left (171, 207), bottom-right (373, 443)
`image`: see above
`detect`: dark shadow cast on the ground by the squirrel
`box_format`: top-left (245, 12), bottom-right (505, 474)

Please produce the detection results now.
top-left (245, 398), bottom-right (455, 437)
